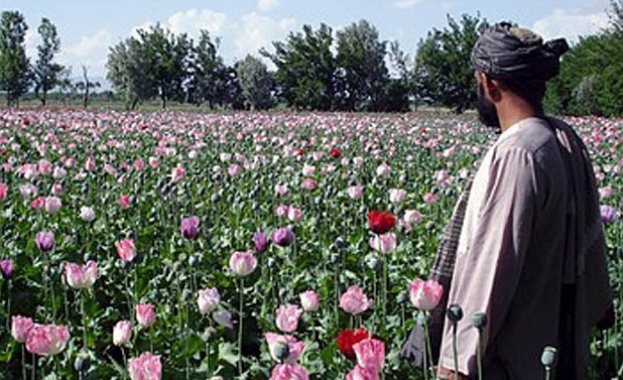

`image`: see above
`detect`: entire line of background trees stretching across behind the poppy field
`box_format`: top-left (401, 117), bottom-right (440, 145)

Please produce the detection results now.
top-left (0, 0), bottom-right (623, 116)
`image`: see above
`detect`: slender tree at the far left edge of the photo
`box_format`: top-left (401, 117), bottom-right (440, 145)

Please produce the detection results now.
top-left (0, 11), bottom-right (32, 106)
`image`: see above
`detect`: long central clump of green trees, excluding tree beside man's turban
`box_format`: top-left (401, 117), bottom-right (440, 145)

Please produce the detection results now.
top-left (107, 21), bottom-right (409, 111)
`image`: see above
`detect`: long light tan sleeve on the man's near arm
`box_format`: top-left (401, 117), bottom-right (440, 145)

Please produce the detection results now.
top-left (440, 147), bottom-right (540, 376)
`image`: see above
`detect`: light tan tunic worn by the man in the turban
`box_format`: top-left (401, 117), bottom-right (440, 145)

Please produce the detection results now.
top-left (440, 118), bottom-right (570, 380)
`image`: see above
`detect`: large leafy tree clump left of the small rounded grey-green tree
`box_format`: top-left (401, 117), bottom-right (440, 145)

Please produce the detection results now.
top-left (106, 24), bottom-right (241, 109)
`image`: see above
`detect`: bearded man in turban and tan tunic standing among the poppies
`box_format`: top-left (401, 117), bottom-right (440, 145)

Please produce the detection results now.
top-left (432, 23), bottom-right (612, 380)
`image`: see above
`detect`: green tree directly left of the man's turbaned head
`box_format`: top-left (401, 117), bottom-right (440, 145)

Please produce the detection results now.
top-left (415, 15), bottom-right (489, 113)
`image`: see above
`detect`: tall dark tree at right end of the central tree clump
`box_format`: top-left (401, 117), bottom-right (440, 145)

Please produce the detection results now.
top-left (336, 20), bottom-right (389, 111)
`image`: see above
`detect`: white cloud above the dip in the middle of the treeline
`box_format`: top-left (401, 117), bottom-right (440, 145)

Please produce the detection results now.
top-left (235, 12), bottom-right (296, 59)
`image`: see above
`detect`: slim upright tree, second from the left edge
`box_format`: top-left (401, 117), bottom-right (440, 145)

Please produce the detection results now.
top-left (33, 17), bottom-right (64, 106)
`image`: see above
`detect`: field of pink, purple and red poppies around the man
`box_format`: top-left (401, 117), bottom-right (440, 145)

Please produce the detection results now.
top-left (0, 109), bottom-right (623, 380)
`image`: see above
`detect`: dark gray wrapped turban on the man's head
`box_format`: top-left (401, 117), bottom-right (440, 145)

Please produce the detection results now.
top-left (471, 23), bottom-right (569, 81)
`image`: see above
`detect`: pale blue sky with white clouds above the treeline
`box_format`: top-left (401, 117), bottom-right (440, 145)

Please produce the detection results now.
top-left (0, 0), bottom-right (609, 80)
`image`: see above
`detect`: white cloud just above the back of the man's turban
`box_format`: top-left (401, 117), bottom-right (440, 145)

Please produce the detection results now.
top-left (532, 8), bottom-right (608, 42)
